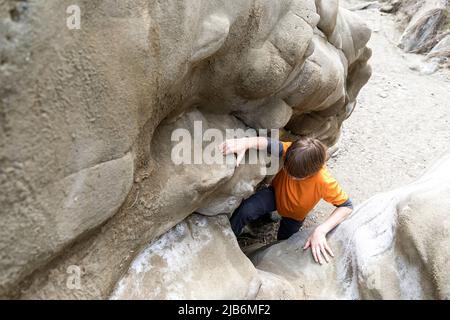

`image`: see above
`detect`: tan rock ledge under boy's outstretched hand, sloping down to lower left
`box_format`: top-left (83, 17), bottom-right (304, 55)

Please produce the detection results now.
top-left (16, 110), bottom-right (265, 298)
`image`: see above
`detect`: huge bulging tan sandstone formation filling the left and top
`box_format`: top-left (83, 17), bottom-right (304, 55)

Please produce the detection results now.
top-left (0, 0), bottom-right (370, 298)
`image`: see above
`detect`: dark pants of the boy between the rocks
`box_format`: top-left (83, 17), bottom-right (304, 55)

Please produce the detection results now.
top-left (230, 186), bottom-right (303, 240)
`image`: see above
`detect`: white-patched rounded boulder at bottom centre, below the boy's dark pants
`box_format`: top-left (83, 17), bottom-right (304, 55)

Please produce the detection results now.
top-left (111, 214), bottom-right (261, 300)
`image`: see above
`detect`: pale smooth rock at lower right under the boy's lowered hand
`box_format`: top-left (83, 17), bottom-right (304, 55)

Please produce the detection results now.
top-left (252, 154), bottom-right (450, 299)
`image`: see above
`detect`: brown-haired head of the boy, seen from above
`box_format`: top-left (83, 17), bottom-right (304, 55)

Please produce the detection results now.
top-left (284, 137), bottom-right (327, 179)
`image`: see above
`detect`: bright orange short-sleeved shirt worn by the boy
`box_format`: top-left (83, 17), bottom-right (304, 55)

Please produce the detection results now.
top-left (272, 142), bottom-right (348, 221)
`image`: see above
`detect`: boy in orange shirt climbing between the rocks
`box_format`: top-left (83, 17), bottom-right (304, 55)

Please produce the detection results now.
top-left (220, 137), bottom-right (353, 264)
